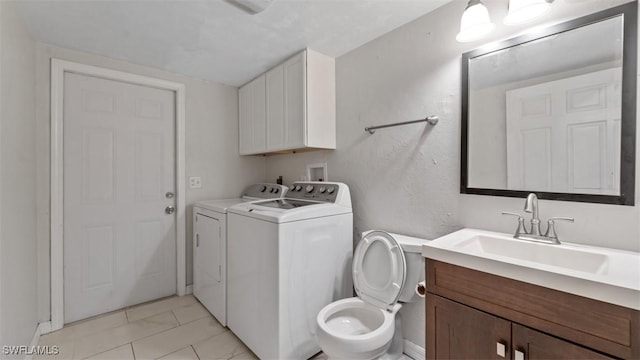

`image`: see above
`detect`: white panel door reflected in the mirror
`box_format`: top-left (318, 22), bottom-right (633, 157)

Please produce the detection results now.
top-left (506, 68), bottom-right (622, 194)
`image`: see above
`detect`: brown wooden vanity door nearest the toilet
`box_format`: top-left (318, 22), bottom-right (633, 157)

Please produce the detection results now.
top-left (426, 294), bottom-right (511, 360)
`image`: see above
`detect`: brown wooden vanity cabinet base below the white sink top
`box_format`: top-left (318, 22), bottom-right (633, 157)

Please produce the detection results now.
top-left (426, 259), bottom-right (640, 360)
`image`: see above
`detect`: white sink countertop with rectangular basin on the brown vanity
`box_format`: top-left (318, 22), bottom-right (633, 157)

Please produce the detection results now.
top-left (422, 229), bottom-right (640, 310)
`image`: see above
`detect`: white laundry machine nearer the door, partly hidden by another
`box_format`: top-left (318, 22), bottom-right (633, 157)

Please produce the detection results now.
top-left (193, 184), bottom-right (288, 326)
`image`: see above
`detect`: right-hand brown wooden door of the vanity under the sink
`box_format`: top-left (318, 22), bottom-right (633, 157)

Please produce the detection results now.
top-left (512, 324), bottom-right (613, 360)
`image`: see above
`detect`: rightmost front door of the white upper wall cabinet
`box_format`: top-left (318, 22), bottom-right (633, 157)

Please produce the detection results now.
top-left (284, 52), bottom-right (307, 149)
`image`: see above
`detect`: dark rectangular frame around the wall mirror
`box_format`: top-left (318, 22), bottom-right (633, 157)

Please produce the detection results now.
top-left (460, 1), bottom-right (638, 206)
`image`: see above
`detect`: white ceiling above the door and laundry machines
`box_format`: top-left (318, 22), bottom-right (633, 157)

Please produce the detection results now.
top-left (19, 0), bottom-right (452, 86)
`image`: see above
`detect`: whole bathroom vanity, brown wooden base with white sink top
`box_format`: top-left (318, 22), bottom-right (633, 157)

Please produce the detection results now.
top-left (423, 229), bottom-right (640, 360)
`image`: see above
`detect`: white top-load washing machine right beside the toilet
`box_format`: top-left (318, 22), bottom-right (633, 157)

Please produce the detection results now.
top-left (227, 182), bottom-right (353, 359)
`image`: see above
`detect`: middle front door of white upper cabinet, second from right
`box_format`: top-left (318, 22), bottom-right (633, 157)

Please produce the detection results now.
top-left (266, 65), bottom-right (287, 151)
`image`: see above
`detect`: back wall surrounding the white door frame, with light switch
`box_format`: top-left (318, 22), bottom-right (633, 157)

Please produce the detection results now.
top-left (36, 43), bottom-right (265, 321)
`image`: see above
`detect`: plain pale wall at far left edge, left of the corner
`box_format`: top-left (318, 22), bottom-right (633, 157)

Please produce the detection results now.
top-left (0, 1), bottom-right (38, 352)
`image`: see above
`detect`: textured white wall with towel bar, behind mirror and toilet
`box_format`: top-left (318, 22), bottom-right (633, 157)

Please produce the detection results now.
top-left (267, 0), bottom-right (640, 346)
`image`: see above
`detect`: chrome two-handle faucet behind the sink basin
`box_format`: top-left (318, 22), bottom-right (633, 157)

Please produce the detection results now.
top-left (502, 193), bottom-right (574, 245)
